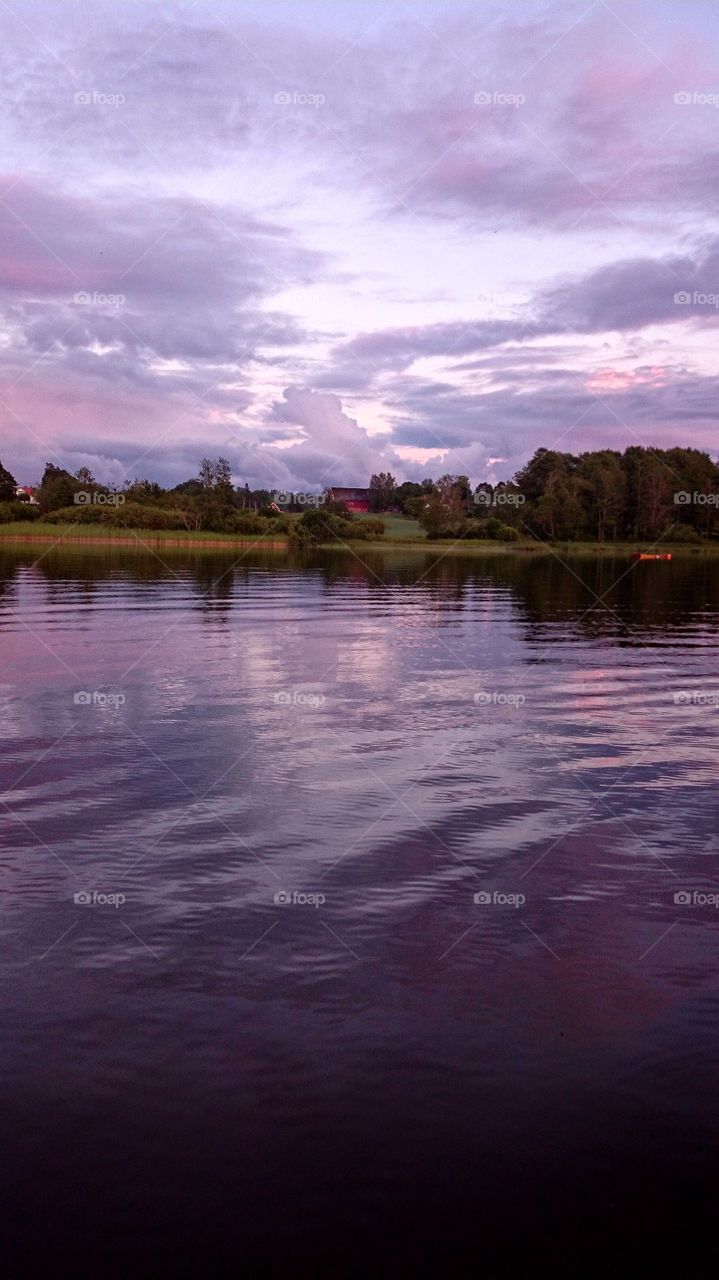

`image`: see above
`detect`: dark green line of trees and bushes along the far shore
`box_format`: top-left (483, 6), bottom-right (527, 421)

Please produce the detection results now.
top-left (0, 445), bottom-right (719, 541)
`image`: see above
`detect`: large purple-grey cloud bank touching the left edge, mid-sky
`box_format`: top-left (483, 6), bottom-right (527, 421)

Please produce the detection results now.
top-left (0, 179), bottom-right (322, 361)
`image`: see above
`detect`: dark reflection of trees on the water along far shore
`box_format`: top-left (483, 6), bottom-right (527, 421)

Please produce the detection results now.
top-left (0, 547), bottom-right (719, 637)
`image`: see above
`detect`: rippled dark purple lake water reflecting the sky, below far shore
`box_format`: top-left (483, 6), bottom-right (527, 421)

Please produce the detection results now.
top-left (0, 549), bottom-right (719, 1276)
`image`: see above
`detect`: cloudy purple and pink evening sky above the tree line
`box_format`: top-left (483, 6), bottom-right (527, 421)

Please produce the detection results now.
top-left (0, 0), bottom-right (719, 492)
